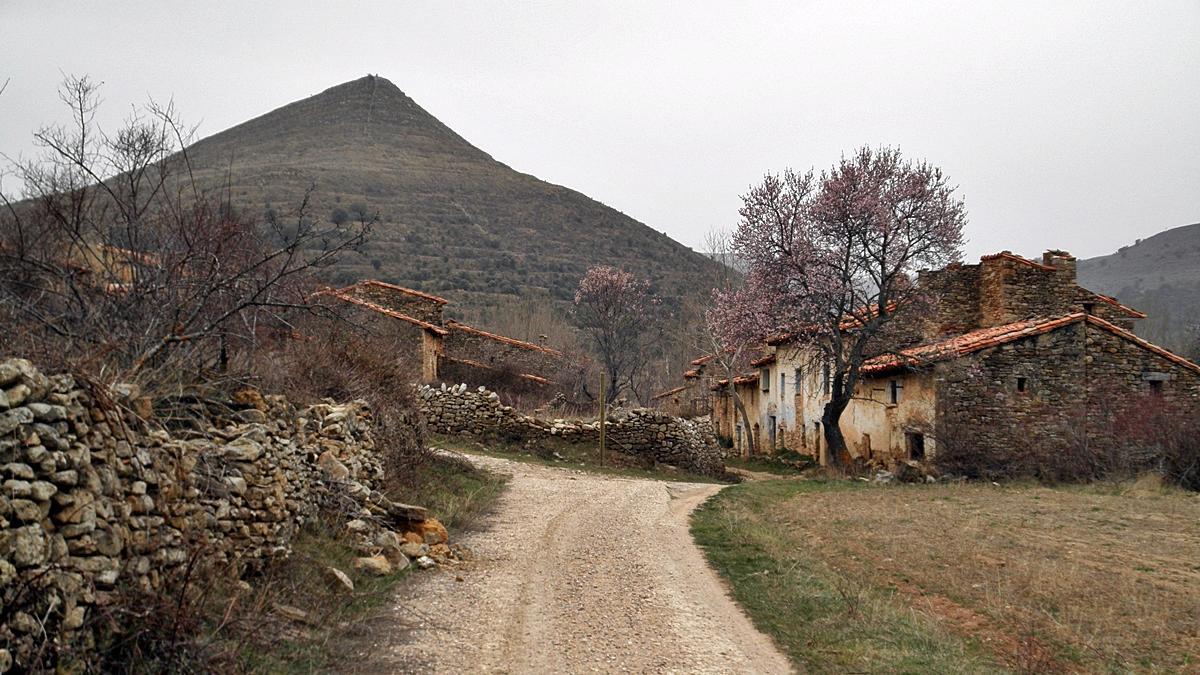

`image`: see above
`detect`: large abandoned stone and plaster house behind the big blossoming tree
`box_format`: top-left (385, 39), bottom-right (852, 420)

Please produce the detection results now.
top-left (694, 251), bottom-right (1200, 464)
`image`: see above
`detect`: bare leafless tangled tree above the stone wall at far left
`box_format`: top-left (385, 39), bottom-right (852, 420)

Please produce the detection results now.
top-left (0, 77), bottom-right (372, 389)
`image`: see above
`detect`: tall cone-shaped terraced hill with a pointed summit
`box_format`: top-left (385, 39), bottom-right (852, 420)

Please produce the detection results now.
top-left (177, 76), bottom-right (718, 317)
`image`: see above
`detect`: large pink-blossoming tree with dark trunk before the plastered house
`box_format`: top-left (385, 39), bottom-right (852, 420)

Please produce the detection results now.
top-left (710, 148), bottom-right (966, 466)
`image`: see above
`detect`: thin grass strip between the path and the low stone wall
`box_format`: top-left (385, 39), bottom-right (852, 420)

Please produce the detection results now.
top-left (430, 435), bottom-right (736, 483)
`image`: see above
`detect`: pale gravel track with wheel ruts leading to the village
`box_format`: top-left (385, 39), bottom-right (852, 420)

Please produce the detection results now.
top-left (348, 458), bottom-right (790, 673)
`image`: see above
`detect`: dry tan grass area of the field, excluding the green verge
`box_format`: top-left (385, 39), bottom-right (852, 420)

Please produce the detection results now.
top-left (772, 480), bottom-right (1200, 673)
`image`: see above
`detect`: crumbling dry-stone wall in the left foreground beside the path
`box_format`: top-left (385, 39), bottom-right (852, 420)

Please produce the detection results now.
top-left (0, 359), bottom-right (424, 673)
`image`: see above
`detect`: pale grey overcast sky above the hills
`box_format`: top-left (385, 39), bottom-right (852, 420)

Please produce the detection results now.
top-left (0, 0), bottom-right (1200, 257)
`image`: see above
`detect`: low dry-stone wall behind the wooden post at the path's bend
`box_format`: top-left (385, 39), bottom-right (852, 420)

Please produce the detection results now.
top-left (418, 384), bottom-right (725, 477)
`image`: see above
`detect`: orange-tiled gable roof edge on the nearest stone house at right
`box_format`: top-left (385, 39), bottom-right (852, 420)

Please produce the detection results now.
top-left (862, 312), bottom-right (1200, 375)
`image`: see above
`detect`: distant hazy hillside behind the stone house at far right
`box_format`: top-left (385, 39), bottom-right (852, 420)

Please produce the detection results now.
top-left (1079, 222), bottom-right (1200, 350)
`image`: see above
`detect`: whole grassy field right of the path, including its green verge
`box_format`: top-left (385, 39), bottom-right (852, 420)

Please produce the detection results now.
top-left (692, 480), bottom-right (1200, 673)
